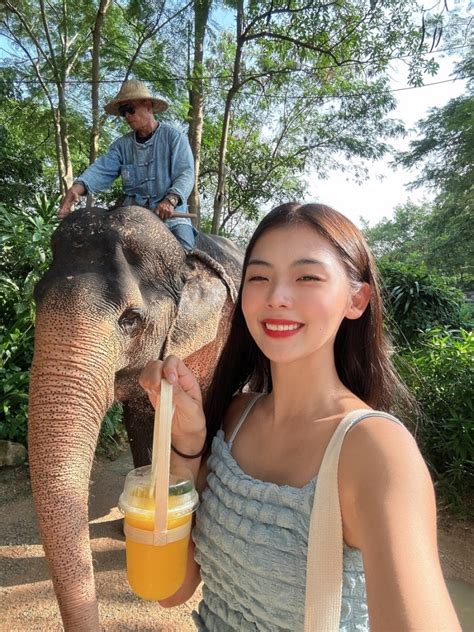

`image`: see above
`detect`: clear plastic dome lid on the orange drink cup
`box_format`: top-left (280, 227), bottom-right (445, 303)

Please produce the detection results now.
top-left (118, 465), bottom-right (199, 517)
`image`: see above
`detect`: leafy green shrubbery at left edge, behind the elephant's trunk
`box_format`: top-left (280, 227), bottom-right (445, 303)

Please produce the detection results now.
top-left (0, 195), bottom-right (125, 455)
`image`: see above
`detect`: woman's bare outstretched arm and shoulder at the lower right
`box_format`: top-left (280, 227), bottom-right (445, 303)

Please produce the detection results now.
top-left (339, 418), bottom-right (461, 632)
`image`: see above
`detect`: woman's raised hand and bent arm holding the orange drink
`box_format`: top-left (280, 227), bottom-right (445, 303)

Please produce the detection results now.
top-left (140, 356), bottom-right (207, 608)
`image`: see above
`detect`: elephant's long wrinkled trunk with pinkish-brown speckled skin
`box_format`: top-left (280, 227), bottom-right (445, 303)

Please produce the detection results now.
top-left (29, 313), bottom-right (118, 632)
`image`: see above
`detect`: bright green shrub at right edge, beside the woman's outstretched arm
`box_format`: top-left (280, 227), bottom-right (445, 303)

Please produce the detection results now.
top-left (397, 328), bottom-right (474, 512)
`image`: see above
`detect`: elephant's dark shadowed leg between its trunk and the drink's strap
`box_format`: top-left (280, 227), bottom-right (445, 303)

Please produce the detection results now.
top-left (123, 393), bottom-right (155, 467)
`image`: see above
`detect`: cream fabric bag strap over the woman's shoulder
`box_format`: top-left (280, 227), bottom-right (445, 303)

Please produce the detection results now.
top-left (304, 410), bottom-right (400, 632)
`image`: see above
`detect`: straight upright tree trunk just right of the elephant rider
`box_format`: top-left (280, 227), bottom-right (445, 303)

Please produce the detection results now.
top-left (188, 0), bottom-right (212, 228)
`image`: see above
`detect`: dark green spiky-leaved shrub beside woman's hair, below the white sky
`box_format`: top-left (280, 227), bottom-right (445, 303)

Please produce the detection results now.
top-left (379, 260), bottom-right (464, 346)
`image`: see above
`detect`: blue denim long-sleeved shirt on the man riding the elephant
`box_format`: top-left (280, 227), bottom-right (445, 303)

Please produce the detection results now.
top-left (76, 123), bottom-right (194, 228)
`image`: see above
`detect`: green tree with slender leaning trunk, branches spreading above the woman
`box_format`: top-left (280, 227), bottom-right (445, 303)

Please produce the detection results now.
top-left (205, 0), bottom-right (442, 232)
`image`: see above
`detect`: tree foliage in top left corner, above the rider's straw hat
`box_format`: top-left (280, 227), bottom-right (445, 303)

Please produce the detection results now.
top-left (0, 0), bottom-right (191, 191)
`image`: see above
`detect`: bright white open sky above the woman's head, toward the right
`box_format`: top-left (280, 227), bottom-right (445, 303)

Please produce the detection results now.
top-left (307, 55), bottom-right (466, 226)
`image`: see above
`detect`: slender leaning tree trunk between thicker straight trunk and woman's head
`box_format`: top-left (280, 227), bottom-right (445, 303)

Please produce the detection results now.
top-left (211, 0), bottom-right (244, 235)
